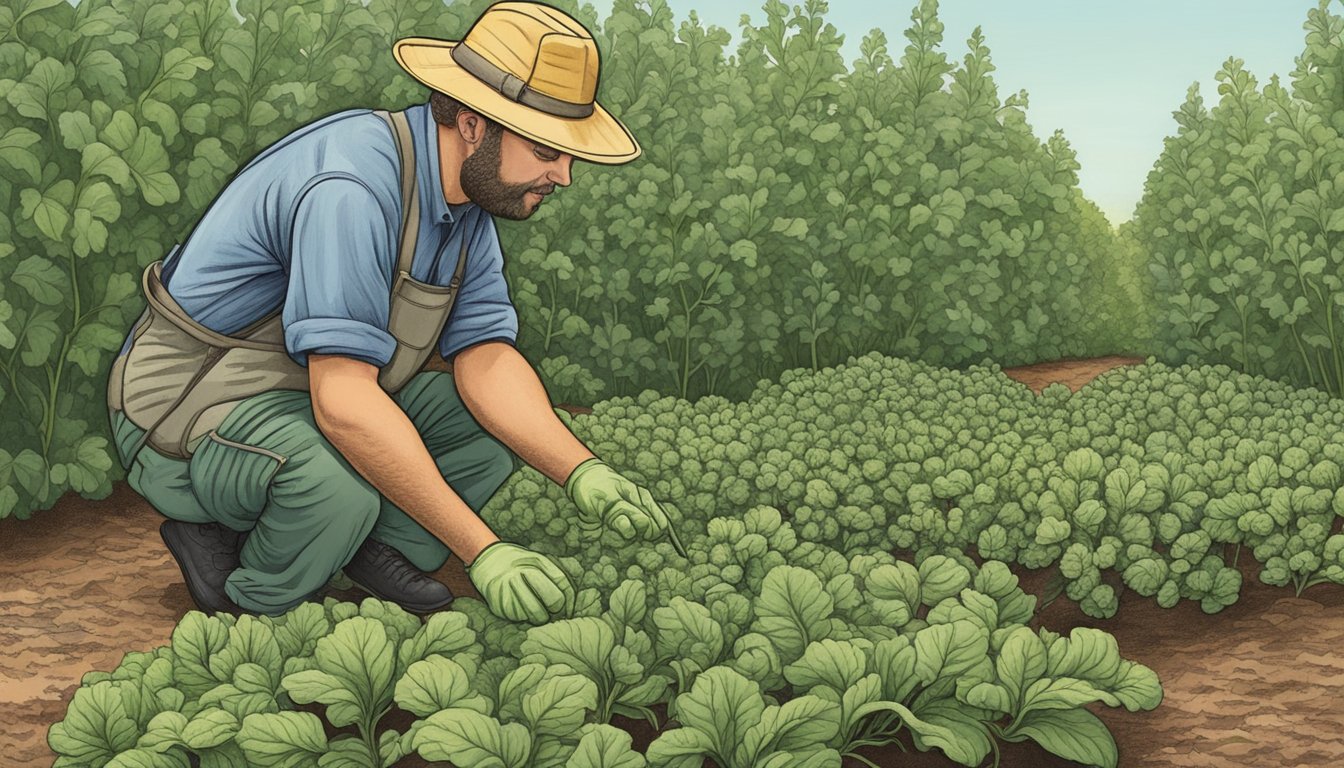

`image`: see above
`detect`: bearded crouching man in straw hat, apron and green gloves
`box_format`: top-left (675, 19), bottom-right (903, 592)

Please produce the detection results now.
top-left (109, 3), bottom-right (682, 623)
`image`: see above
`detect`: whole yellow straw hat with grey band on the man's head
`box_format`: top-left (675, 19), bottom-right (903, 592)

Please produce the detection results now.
top-left (392, 1), bottom-right (640, 165)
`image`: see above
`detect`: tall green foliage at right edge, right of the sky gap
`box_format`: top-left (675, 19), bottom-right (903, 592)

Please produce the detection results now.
top-left (1121, 0), bottom-right (1344, 397)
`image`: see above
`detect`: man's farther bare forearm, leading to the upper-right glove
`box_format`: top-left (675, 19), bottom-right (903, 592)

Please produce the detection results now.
top-left (453, 342), bottom-right (594, 484)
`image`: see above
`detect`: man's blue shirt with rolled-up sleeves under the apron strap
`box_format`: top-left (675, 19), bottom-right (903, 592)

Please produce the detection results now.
top-left (144, 102), bottom-right (517, 366)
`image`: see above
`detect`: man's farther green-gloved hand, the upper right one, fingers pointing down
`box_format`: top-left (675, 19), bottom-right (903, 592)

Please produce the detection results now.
top-left (564, 459), bottom-right (685, 557)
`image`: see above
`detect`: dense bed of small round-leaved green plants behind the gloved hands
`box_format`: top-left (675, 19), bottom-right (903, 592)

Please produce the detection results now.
top-left (505, 354), bottom-right (1344, 617)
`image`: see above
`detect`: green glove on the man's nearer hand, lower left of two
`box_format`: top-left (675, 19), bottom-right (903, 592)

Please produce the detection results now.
top-left (466, 541), bottom-right (574, 624)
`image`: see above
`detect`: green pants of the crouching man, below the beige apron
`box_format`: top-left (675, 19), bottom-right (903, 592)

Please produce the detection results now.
top-left (112, 371), bottom-right (521, 615)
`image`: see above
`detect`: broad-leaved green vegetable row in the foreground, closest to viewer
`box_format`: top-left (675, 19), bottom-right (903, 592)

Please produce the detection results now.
top-left (48, 555), bottom-right (1161, 768)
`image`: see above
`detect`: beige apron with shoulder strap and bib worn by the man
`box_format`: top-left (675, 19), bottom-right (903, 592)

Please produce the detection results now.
top-left (108, 110), bottom-right (468, 463)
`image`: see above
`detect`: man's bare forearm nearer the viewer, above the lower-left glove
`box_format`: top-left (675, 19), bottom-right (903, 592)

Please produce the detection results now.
top-left (313, 355), bottom-right (499, 562)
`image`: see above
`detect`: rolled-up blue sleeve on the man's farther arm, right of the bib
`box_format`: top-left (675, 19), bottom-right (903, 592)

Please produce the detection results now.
top-left (438, 217), bottom-right (517, 359)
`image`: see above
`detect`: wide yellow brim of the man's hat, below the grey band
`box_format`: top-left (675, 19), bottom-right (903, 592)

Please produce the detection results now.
top-left (392, 38), bottom-right (641, 165)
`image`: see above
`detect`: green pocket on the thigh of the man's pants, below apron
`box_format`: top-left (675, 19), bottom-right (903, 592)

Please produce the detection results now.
top-left (191, 430), bottom-right (285, 530)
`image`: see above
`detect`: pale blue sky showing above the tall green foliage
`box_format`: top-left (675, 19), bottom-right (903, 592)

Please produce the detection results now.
top-left (589, 0), bottom-right (1317, 225)
